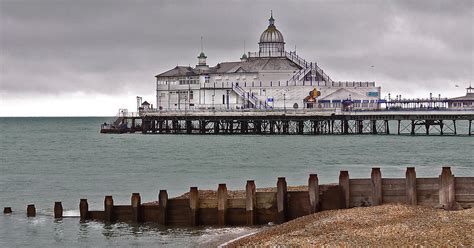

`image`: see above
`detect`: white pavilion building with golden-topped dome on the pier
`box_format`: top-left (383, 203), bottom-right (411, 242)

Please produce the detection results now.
top-left (156, 15), bottom-right (384, 110)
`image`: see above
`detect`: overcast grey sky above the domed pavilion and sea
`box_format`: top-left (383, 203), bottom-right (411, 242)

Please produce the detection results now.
top-left (0, 0), bottom-right (474, 116)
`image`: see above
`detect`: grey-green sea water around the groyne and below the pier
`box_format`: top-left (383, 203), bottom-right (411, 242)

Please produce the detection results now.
top-left (0, 118), bottom-right (474, 247)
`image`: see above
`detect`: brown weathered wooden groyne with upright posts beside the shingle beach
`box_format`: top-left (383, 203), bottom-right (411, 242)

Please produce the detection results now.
top-left (65, 167), bottom-right (474, 226)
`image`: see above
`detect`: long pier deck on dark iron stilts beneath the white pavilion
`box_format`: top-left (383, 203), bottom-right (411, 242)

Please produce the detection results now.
top-left (112, 109), bottom-right (474, 136)
